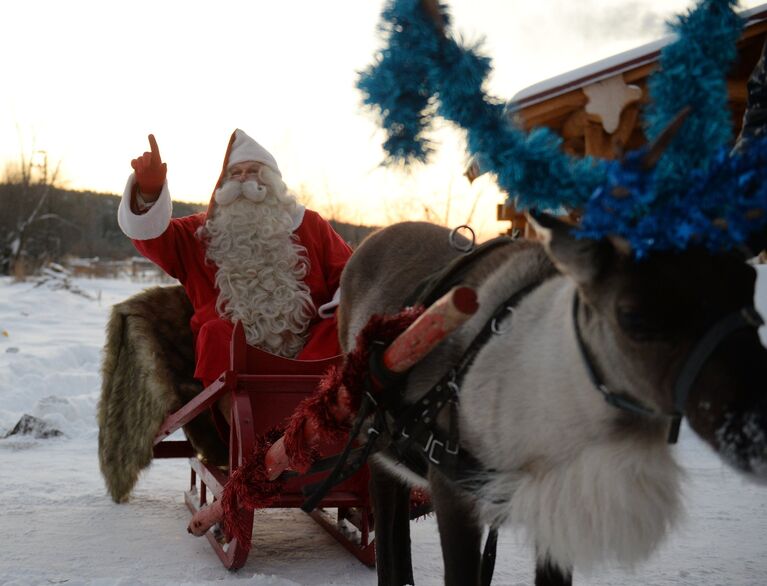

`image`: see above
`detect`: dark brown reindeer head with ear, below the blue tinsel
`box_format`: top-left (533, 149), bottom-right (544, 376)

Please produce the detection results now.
top-left (533, 210), bottom-right (767, 481)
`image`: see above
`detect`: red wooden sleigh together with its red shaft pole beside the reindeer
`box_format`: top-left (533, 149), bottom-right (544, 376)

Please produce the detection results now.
top-left (142, 287), bottom-right (477, 569)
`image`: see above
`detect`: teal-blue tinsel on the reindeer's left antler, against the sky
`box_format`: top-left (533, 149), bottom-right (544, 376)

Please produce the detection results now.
top-left (357, 0), bottom-right (604, 208)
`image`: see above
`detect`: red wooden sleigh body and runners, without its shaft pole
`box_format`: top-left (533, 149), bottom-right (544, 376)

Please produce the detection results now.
top-left (154, 325), bottom-right (375, 570)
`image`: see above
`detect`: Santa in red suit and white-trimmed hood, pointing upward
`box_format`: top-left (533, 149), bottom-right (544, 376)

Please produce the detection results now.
top-left (118, 129), bottom-right (351, 386)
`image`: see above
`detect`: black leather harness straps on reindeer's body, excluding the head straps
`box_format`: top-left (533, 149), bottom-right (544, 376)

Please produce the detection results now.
top-left (301, 233), bottom-right (542, 586)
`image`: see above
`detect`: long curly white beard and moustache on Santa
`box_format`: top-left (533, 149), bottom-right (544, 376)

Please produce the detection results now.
top-left (200, 169), bottom-right (316, 358)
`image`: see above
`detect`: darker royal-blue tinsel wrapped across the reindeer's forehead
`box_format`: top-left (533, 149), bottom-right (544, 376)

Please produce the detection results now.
top-left (579, 139), bottom-right (767, 257)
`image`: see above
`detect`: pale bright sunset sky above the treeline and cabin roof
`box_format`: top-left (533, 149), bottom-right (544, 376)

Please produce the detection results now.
top-left (0, 0), bottom-right (760, 235)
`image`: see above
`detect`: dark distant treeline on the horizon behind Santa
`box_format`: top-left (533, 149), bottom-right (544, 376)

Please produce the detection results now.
top-left (0, 183), bottom-right (374, 274)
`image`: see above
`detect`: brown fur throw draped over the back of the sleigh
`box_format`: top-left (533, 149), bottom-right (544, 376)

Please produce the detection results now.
top-left (98, 286), bottom-right (227, 503)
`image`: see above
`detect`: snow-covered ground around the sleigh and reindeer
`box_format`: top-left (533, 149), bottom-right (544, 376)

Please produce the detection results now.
top-left (0, 267), bottom-right (767, 586)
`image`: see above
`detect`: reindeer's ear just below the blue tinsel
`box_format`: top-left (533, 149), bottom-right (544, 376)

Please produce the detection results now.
top-left (527, 211), bottom-right (617, 285)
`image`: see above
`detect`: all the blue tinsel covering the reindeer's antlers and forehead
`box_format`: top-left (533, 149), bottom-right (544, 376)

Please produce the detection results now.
top-left (358, 0), bottom-right (767, 256)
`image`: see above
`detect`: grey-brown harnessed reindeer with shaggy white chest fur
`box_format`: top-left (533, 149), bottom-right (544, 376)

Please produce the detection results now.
top-left (339, 214), bottom-right (767, 586)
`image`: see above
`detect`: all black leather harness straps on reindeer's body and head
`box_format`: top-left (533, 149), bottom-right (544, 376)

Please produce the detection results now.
top-left (302, 230), bottom-right (763, 586)
